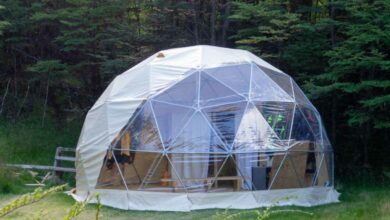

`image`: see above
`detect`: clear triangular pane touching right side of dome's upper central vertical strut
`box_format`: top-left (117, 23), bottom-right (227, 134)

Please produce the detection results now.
top-left (199, 72), bottom-right (245, 107)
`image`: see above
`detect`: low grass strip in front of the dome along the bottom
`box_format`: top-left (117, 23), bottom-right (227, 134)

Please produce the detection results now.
top-left (0, 186), bottom-right (390, 220)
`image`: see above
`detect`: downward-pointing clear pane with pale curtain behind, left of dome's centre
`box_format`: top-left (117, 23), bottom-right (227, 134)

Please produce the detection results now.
top-left (152, 101), bottom-right (195, 145)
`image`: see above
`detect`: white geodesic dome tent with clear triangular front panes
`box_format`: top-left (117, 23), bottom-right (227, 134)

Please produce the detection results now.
top-left (73, 46), bottom-right (339, 211)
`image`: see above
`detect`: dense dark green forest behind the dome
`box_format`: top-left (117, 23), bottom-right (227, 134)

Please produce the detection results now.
top-left (0, 0), bottom-right (390, 181)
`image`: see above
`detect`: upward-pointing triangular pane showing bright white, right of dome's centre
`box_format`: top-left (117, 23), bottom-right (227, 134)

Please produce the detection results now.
top-left (233, 103), bottom-right (280, 152)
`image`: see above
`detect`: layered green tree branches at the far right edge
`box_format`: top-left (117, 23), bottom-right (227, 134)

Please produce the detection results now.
top-left (317, 1), bottom-right (390, 128)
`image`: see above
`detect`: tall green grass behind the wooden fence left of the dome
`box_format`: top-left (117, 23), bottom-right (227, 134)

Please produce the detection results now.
top-left (0, 113), bottom-right (81, 165)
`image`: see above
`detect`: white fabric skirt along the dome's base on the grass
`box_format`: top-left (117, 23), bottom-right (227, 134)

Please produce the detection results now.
top-left (72, 187), bottom-right (340, 212)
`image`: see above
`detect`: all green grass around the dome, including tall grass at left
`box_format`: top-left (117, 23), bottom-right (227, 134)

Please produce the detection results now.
top-left (0, 115), bottom-right (390, 220)
